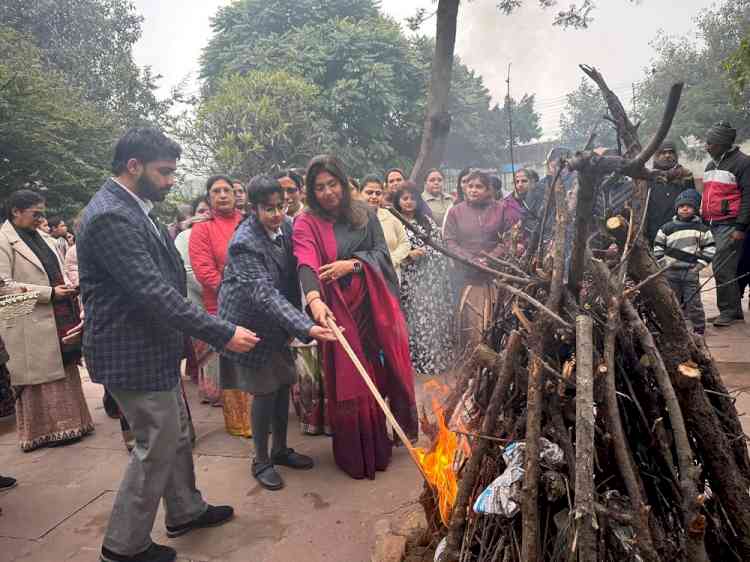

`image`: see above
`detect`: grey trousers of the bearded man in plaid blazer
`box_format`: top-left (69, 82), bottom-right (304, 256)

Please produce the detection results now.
top-left (104, 384), bottom-right (208, 556)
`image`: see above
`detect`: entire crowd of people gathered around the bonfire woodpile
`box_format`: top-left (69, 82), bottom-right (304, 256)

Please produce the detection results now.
top-left (0, 123), bottom-right (750, 562)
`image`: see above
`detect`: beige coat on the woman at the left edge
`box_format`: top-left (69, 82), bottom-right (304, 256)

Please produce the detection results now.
top-left (0, 221), bottom-right (65, 386)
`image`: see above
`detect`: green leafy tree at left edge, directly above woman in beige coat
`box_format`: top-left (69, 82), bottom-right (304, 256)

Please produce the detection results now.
top-left (0, 26), bottom-right (116, 214)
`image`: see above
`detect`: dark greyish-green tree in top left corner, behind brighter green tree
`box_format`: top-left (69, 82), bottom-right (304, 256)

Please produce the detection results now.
top-left (0, 0), bottom-right (169, 127)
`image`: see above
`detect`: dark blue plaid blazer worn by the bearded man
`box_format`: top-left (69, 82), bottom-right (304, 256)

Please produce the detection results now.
top-left (76, 179), bottom-right (235, 391)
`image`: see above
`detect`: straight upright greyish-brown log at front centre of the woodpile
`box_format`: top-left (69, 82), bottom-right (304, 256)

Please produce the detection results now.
top-left (571, 316), bottom-right (597, 562)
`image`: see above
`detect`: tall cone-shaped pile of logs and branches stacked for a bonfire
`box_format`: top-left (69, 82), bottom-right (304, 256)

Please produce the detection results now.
top-left (408, 66), bottom-right (750, 562)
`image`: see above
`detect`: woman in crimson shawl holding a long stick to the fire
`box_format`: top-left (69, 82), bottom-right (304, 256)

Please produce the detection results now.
top-left (294, 155), bottom-right (418, 479)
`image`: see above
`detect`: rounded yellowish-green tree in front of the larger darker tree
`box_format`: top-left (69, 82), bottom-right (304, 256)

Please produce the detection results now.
top-left (179, 70), bottom-right (333, 179)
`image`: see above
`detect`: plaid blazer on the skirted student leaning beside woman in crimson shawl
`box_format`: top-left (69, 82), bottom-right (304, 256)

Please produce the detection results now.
top-left (219, 214), bottom-right (313, 368)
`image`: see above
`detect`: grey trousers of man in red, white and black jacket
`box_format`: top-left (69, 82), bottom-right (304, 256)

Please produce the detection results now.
top-left (711, 224), bottom-right (742, 318)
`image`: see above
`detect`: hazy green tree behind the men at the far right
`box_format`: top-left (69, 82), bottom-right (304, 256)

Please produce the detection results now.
top-left (638, 0), bottom-right (750, 147)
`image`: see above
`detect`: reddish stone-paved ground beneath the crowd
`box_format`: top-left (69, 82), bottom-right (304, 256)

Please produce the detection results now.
top-left (0, 276), bottom-right (750, 562)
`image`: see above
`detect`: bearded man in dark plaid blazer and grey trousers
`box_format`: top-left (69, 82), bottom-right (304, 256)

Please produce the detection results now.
top-left (77, 129), bottom-right (259, 562)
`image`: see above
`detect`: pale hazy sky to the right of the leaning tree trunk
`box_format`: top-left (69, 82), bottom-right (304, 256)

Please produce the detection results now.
top-left (444, 0), bottom-right (712, 138)
